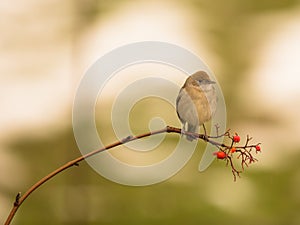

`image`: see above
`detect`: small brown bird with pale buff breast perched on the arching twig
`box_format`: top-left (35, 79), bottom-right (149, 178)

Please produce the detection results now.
top-left (176, 71), bottom-right (217, 141)
